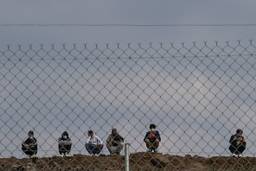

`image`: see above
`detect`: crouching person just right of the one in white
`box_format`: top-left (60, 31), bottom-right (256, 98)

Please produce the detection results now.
top-left (106, 128), bottom-right (124, 155)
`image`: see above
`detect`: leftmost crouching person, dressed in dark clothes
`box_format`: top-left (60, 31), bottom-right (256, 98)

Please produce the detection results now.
top-left (21, 131), bottom-right (37, 158)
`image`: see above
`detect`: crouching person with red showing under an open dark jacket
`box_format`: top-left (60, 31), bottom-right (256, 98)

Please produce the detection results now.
top-left (144, 124), bottom-right (161, 152)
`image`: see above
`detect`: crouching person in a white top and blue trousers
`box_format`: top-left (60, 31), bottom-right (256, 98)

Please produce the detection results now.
top-left (85, 130), bottom-right (103, 155)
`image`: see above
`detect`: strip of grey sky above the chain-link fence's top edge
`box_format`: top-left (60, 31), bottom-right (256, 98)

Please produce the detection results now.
top-left (0, 0), bottom-right (256, 44)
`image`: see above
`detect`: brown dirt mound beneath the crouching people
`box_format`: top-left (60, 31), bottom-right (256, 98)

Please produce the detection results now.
top-left (0, 153), bottom-right (256, 171)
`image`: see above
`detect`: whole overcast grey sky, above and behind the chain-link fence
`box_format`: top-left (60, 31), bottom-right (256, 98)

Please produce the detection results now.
top-left (0, 0), bottom-right (256, 157)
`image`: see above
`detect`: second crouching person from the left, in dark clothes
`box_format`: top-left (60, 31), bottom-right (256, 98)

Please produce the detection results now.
top-left (58, 131), bottom-right (72, 156)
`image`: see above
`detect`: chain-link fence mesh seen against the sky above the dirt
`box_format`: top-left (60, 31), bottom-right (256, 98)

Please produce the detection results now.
top-left (0, 41), bottom-right (256, 170)
